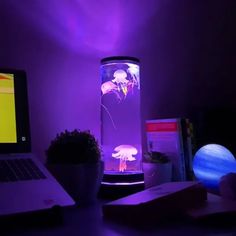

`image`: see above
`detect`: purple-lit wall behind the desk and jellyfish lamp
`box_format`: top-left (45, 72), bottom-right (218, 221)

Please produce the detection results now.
top-left (0, 0), bottom-right (236, 159)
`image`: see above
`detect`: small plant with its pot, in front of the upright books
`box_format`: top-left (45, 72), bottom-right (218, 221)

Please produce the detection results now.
top-left (143, 151), bottom-right (172, 188)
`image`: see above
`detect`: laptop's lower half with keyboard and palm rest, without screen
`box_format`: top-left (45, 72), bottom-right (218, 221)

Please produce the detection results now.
top-left (0, 154), bottom-right (74, 216)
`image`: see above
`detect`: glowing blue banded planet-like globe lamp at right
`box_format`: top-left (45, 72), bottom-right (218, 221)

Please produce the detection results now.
top-left (193, 144), bottom-right (236, 191)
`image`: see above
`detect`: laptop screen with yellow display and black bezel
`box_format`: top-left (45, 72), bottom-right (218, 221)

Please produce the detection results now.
top-left (0, 69), bottom-right (31, 154)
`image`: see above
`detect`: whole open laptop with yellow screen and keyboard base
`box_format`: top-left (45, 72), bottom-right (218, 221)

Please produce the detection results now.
top-left (0, 69), bottom-right (75, 216)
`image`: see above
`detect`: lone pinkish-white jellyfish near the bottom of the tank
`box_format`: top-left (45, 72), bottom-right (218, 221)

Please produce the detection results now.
top-left (112, 145), bottom-right (138, 172)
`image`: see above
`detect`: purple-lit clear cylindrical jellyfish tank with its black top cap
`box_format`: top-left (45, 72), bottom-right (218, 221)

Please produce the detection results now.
top-left (100, 56), bottom-right (142, 184)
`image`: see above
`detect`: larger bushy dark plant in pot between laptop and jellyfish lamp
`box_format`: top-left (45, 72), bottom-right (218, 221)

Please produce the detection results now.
top-left (46, 129), bottom-right (104, 204)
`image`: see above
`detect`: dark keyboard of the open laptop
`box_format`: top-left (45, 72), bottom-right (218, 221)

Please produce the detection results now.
top-left (0, 158), bottom-right (46, 182)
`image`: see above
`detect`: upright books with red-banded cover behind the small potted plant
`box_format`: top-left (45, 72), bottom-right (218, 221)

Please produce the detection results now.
top-left (146, 118), bottom-right (193, 181)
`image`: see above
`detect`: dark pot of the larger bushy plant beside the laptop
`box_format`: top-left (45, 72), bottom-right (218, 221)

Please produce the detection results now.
top-left (47, 161), bottom-right (104, 205)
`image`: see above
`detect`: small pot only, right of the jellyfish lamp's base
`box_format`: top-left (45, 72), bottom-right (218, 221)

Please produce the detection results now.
top-left (143, 162), bottom-right (172, 188)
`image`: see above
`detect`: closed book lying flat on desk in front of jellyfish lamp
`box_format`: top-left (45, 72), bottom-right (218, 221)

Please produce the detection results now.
top-left (102, 181), bottom-right (207, 224)
